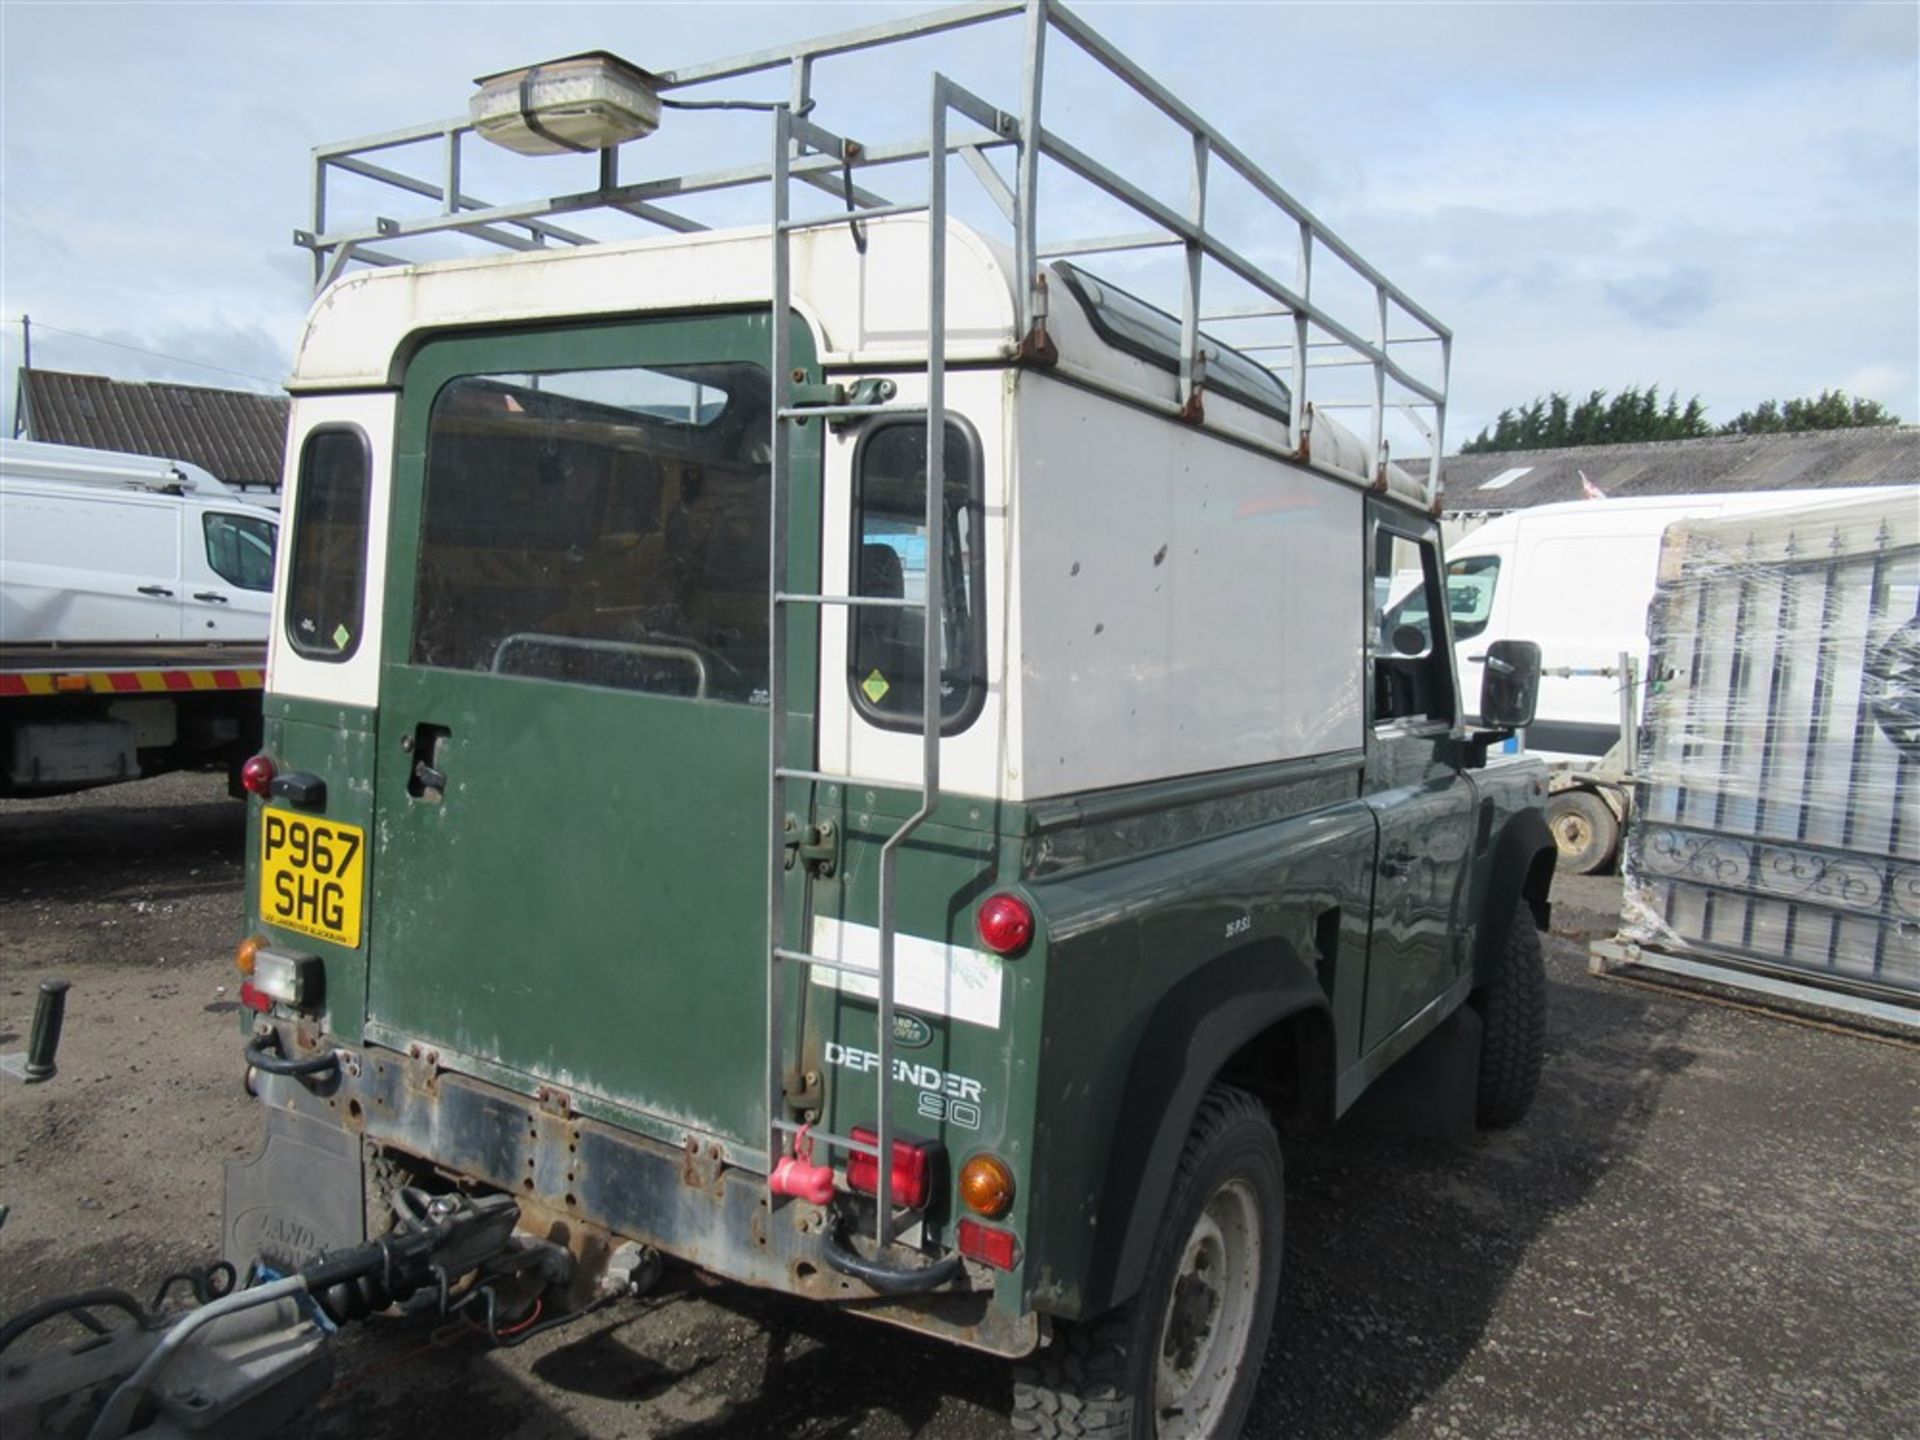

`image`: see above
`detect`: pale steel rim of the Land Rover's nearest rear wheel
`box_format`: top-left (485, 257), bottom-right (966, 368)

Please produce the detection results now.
top-left (1154, 1179), bottom-right (1261, 1440)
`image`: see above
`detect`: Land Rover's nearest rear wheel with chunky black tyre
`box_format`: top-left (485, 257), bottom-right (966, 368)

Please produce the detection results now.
top-left (1014, 1085), bottom-right (1284, 1440)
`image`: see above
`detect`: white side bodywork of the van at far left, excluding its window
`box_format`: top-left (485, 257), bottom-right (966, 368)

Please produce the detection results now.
top-left (0, 467), bottom-right (278, 645)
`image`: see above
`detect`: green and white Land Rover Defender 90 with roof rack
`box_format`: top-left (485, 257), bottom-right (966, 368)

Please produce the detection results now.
top-left (227, 0), bottom-right (1553, 1436)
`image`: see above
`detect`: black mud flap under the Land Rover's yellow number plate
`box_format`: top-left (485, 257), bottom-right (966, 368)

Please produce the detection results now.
top-left (221, 1108), bottom-right (367, 1275)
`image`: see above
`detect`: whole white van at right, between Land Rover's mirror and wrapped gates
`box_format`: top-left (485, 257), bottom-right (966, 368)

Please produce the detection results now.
top-left (1428, 488), bottom-right (1885, 874)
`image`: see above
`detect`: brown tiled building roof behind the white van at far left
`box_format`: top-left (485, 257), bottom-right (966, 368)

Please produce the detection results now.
top-left (19, 369), bottom-right (288, 486)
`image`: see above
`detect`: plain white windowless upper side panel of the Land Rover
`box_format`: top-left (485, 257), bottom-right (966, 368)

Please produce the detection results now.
top-left (1008, 372), bottom-right (1365, 799)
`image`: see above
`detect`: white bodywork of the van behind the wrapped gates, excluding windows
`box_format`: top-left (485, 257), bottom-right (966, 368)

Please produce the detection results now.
top-left (1448, 488), bottom-right (1896, 764)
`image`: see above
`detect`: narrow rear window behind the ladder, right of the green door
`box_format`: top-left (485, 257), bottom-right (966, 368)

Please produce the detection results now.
top-left (847, 420), bottom-right (987, 735)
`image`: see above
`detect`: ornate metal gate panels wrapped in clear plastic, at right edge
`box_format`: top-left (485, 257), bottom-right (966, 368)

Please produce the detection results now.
top-left (1622, 488), bottom-right (1920, 1002)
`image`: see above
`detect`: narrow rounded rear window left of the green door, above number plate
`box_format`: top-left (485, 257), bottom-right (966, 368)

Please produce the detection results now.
top-left (286, 428), bottom-right (372, 660)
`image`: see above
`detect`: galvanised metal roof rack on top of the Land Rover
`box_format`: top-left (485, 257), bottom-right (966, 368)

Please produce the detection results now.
top-left (294, 0), bottom-right (1453, 507)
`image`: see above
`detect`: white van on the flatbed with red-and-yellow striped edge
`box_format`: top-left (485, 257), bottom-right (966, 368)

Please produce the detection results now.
top-left (0, 442), bottom-right (280, 645)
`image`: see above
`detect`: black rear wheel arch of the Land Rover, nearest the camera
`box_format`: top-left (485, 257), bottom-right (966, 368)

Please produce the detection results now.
top-left (1079, 941), bottom-right (1334, 1317)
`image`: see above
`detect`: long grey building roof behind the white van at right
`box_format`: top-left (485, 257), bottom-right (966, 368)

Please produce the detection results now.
top-left (1442, 424), bottom-right (1920, 515)
